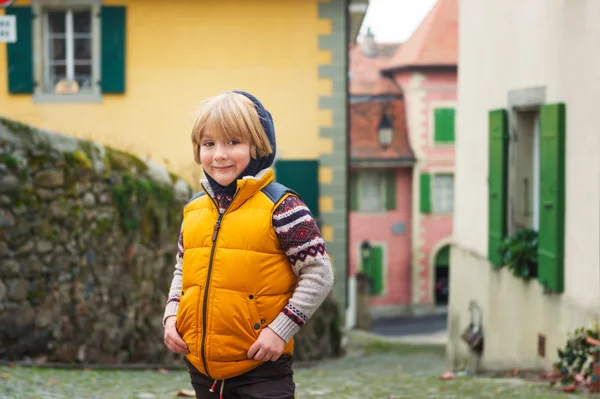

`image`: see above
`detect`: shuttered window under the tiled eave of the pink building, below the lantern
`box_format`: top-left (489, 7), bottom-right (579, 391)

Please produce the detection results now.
top-left (350, 170), bottom-right (396, 212)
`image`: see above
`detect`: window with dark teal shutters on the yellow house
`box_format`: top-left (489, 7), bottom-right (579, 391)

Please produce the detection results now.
top-left (5, 0), bottom-right (127, 102)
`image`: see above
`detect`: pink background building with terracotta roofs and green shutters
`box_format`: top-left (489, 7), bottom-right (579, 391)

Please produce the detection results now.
top-left (349, 0), bottom-right (458, 316)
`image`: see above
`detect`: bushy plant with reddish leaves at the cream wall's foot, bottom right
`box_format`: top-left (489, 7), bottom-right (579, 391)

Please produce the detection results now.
top-left (554, 325), bottom-right (599, 385)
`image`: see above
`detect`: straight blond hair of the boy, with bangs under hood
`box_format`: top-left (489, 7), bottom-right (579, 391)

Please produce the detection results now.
top-left (192, 92), bottom-right (273, 164)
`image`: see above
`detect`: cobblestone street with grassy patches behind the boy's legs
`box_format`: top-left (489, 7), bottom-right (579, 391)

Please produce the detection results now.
top-left (0, 343), bottom-right (584, 399)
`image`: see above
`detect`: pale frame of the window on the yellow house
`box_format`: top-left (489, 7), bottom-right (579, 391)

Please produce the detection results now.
top-left (31, 0), bottom-right (102, 103)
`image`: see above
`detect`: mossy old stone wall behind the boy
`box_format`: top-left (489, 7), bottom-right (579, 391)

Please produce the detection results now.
top-left (0, 118), bottom-right (341, 364)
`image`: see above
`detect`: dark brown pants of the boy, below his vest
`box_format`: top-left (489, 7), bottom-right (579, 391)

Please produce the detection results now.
top-left (184, 355), bottom-right (296, 399)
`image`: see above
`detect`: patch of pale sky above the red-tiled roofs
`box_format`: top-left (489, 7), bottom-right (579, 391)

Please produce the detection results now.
top-left (359, 0), bottom-right (436, 43)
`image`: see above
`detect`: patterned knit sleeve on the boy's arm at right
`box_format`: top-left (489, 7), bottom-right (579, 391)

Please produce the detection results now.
top-left (269, 196), bottom-right (333, 342)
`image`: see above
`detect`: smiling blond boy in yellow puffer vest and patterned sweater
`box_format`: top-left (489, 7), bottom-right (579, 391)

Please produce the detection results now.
top-left (163, 91), bottom-right (333, 399)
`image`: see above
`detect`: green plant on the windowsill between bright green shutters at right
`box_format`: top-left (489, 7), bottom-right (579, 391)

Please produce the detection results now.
top-left (498, 229), bottom-right (538, 279)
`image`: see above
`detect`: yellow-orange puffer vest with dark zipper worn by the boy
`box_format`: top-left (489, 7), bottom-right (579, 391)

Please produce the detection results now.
top-left (177, 170), bottom-right (298, 380)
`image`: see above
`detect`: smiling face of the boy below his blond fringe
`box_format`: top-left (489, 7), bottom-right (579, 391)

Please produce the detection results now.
top-left (200, 132), bottom-right (250, 186)
